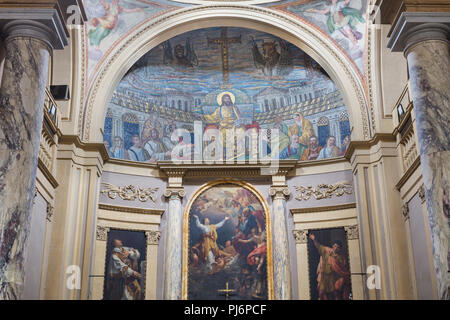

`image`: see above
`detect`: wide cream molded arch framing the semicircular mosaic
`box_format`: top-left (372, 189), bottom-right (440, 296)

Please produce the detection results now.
top-left (79, 5), bottom-right (372, 142)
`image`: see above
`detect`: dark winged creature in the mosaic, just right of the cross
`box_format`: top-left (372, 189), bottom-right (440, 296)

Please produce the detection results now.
top-left (251, 37), bottom-right (293, 76)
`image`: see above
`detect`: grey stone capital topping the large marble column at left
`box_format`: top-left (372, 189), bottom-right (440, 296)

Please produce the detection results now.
top-left (0, 8), bottom-right (69, 51)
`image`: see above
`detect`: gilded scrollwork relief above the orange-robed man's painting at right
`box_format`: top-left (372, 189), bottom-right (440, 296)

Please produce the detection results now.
top-left (294, 181), bottom-right (353, 201)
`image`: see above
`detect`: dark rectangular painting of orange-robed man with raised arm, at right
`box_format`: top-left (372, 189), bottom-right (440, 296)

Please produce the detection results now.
top-left (308, 228), bottom-right (352, 300)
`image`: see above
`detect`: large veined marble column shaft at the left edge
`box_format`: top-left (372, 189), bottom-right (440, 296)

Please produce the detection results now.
top-left (0, 25), bottom-right (52, 300)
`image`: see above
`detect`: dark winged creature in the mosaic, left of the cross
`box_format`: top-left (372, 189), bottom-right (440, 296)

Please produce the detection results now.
top-left (162, 38), bottom-right (198, 68)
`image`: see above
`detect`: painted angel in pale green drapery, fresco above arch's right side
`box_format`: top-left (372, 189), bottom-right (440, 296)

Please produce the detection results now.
top-left (306, 0), bottom-right (365, 49)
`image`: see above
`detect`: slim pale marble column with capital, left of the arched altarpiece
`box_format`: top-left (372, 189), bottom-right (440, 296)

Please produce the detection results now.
top-left (164, 188), bottom-right (186, 300)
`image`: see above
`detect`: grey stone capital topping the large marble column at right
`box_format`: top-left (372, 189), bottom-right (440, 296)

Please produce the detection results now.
top-left (387, 12), bottom-right (450, 56)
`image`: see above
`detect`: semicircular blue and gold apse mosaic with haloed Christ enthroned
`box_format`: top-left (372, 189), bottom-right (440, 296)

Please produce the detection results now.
top-left (104, 27), bottom-right (351, 163)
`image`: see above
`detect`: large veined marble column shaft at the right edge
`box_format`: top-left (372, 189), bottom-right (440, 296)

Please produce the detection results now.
top-left (405, 25), bottom-right (450, 299)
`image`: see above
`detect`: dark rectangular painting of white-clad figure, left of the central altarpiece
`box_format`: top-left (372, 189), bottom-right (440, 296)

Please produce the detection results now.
top-left (103, 229), bottom-right (147, 300)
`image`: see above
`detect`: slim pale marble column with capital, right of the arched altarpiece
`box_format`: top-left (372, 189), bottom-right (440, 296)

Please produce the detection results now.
top-left (269, 186), bottom-right (291, 300)
